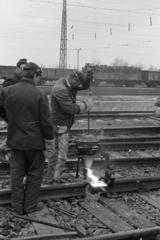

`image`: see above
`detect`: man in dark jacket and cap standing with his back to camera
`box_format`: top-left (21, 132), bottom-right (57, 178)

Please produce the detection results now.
top-left (0, 62), bottom-right (54, 215)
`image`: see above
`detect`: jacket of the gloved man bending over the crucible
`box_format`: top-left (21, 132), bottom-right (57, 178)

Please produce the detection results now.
top-left (51, 78), bottom-right (80, 127)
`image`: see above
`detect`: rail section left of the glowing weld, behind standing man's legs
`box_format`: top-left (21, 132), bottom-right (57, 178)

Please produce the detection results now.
top-left (0, 182), bottom-right (88, 205)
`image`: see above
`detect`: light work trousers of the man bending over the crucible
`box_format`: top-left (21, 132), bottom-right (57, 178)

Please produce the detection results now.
top-left (48, 127), bottom-right (69, 183)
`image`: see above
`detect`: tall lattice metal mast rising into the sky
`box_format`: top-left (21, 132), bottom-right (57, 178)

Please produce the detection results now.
top-left (59, 0), bottom-right (67, 68)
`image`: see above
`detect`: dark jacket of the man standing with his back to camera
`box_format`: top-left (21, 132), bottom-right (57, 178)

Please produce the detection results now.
top-left (0, 78), bottom-right (54, 150)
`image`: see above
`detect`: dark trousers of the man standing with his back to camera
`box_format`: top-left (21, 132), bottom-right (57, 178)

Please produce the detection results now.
top-left (10, 149), bottom-right (45, 214)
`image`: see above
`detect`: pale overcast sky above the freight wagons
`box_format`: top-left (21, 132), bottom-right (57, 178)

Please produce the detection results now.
top-left (0, 0), bottom-right (160, 69)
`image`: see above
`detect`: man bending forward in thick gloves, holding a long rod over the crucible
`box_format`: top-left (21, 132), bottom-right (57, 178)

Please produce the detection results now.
top-left (48, 68), bottom-right (93, 184)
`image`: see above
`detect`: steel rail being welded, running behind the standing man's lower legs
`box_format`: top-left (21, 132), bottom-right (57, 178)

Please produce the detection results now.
top-left (0, 177), bottom-right (160, 205)
